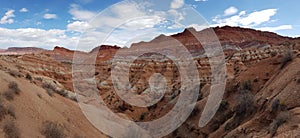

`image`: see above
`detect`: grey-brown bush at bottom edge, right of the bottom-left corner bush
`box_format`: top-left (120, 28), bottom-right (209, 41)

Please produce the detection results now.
top-left (41, 121), bottom-right (66, 138)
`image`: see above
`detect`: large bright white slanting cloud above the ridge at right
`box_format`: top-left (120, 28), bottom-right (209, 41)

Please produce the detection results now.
top-left (213, 9), bottom-right (277, 27)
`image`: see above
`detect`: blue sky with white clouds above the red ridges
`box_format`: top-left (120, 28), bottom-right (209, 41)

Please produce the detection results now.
top-left (0, 0), bottom-right (300, 51)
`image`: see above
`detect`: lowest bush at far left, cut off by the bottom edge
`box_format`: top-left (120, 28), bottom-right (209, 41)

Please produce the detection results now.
top-left (3, 120), bottom-right (20, 138)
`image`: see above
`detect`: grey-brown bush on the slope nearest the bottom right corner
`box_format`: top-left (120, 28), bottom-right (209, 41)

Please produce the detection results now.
top-left (269, 111), bottom-right (290, 136)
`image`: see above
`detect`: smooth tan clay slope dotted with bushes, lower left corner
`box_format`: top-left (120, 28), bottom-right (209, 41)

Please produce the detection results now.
top-left (0, 70), bottom-right (104, 138)
